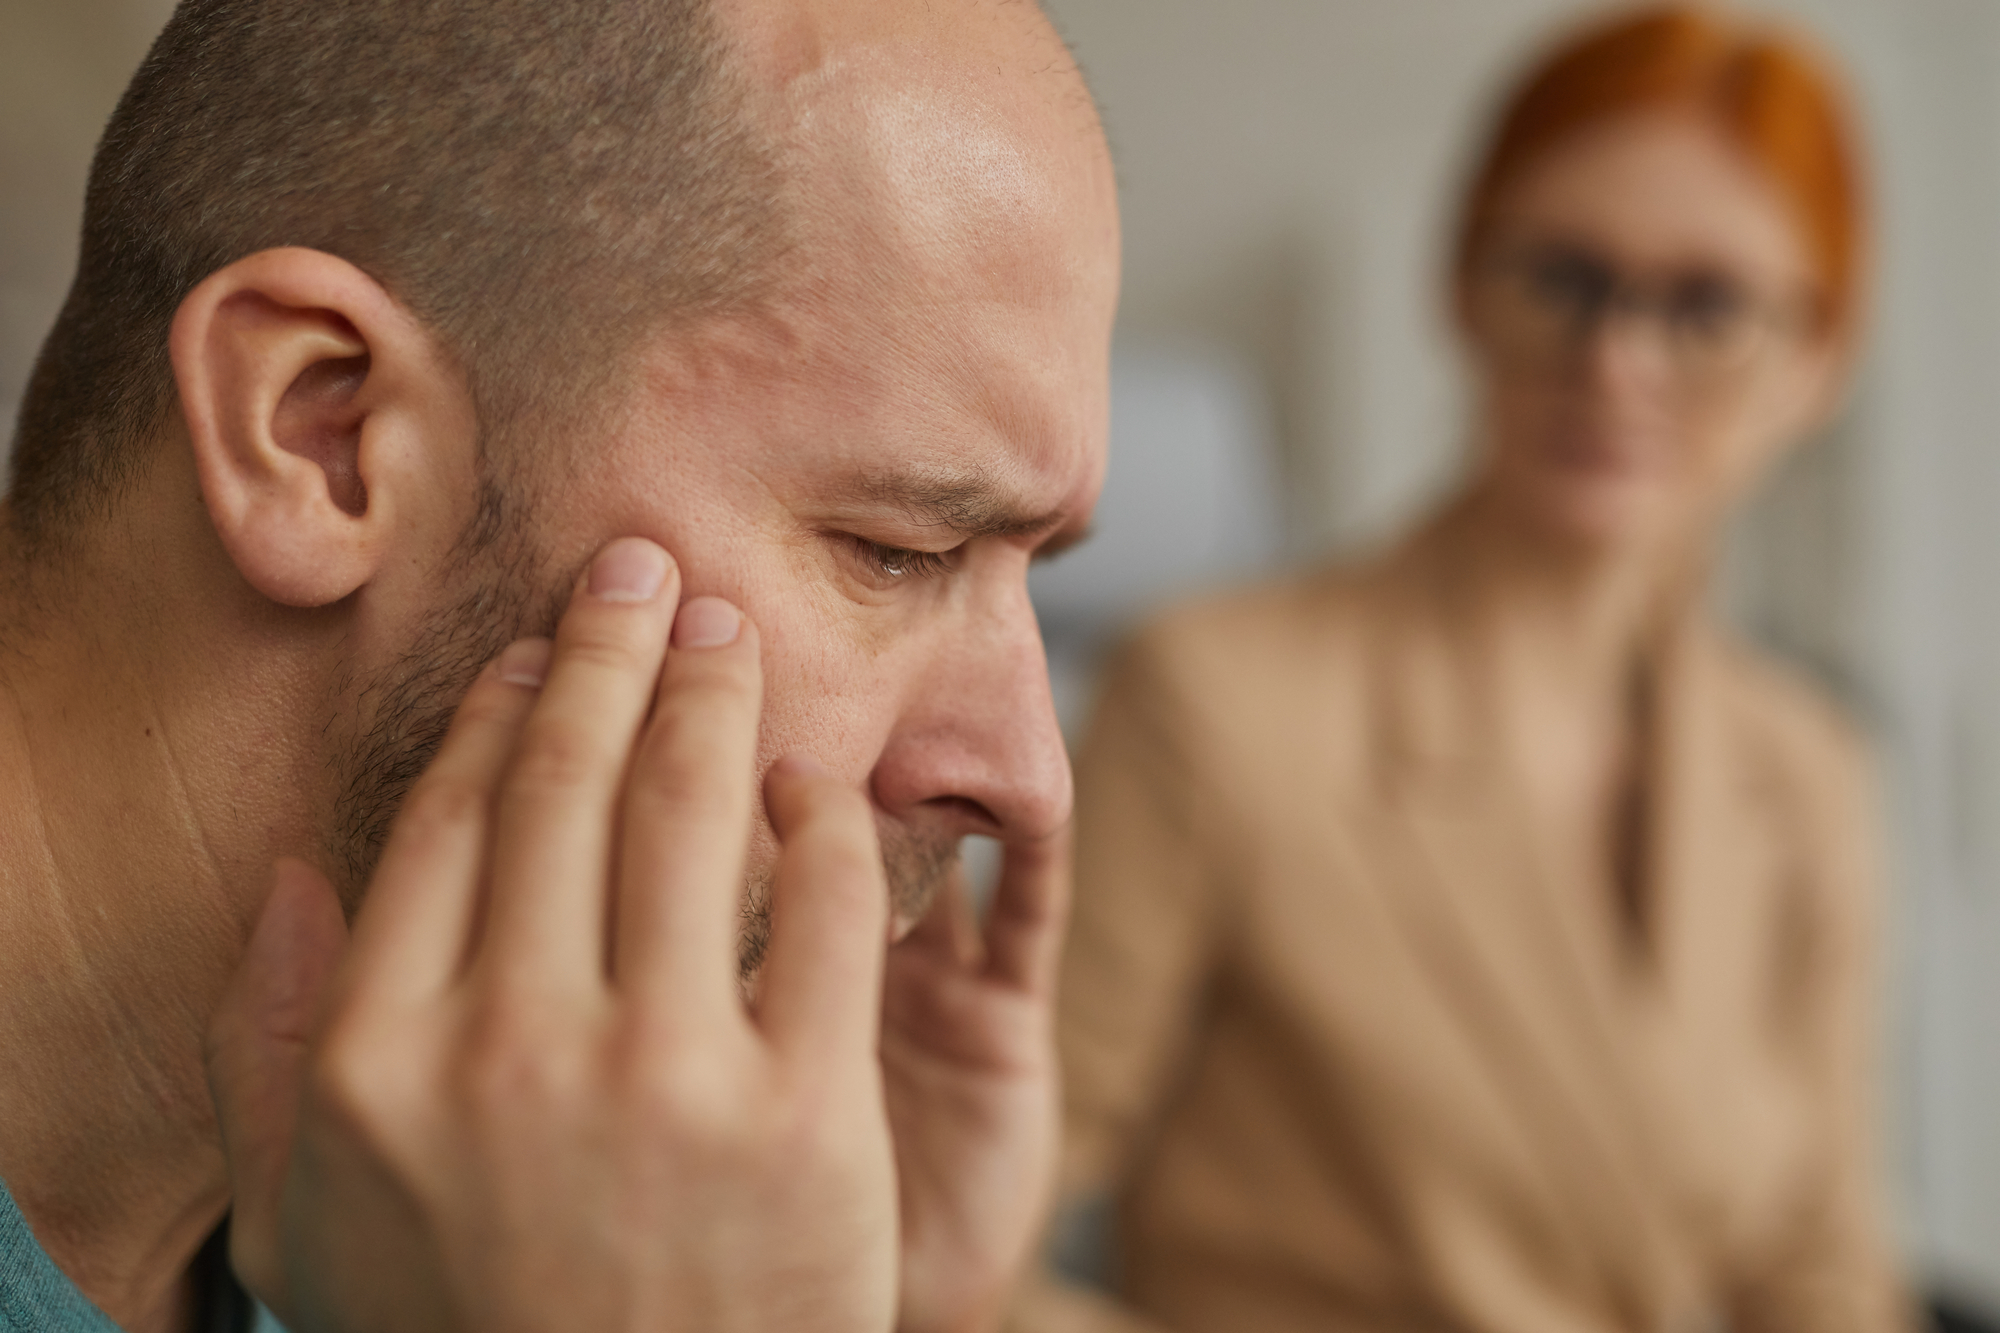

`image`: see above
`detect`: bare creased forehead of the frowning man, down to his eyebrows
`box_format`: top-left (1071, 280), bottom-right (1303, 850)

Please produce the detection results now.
top-left (632, 0), bottom-right (1118, 536)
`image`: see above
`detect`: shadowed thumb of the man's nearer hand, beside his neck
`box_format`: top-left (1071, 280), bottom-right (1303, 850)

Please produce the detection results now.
top-left (208, 859), bottom-right (348, 1307)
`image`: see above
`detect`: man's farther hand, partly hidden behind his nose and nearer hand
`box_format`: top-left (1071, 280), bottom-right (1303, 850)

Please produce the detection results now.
top-left (882, 835), bottom-right (1070, 1333)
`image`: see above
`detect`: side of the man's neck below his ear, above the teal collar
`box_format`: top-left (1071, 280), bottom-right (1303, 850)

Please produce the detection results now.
top-left (0, 552), bottom-right (246, 1329)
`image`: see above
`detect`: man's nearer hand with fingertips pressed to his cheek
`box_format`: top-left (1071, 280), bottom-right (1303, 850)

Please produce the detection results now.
top-left (210, 540), bottom-right (898, 1333)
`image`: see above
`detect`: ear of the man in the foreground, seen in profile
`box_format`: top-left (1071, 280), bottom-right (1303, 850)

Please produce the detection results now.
top-left (170, 248), bottom-right (476, 606)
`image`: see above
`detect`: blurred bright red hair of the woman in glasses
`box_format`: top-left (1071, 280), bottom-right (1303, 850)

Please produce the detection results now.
top-left (1458, 4), bottom-right (1868, 330)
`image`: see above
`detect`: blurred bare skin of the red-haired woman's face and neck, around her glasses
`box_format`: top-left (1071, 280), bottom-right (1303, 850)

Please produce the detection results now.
top-left (1450, 114), bottom-right (1852, 892)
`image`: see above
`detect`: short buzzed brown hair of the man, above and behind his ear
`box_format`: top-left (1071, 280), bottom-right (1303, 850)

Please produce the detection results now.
top-left (10, 0), bottom-right (784, 540)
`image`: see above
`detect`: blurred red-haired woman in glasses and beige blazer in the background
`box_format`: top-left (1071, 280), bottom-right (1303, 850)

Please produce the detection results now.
top-left (1020, 6), bottom-right (1908, 1333)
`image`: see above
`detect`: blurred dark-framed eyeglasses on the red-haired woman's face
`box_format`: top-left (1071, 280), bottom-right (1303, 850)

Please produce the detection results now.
top-left (1482, 244), bottom-right (1812, 386)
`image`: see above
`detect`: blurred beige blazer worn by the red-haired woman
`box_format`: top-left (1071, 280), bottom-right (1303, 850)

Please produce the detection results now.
top-left (1014, 540), bottom-right (1908, 1333)
